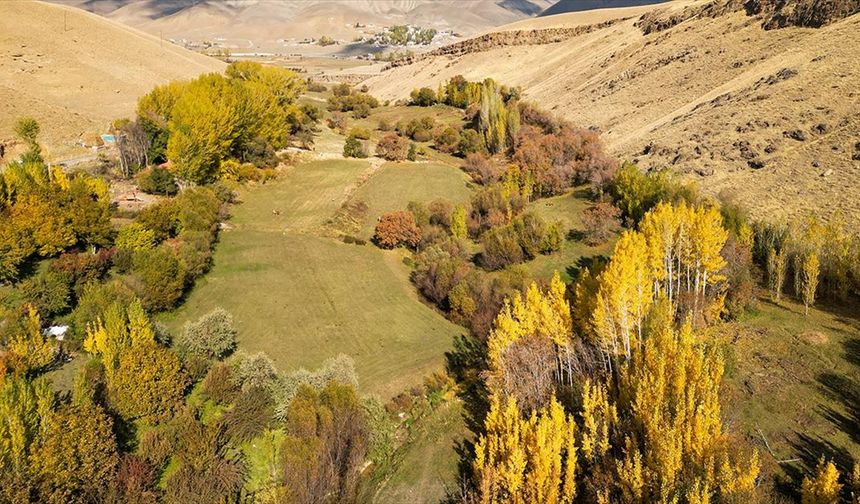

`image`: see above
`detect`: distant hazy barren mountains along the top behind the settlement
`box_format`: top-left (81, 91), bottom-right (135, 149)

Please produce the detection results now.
top-left (65, 0), bottom-right (553, 46)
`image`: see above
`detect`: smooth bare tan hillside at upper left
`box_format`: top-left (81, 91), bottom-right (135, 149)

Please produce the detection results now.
top-left (0, 1), bottom-right (224, 162)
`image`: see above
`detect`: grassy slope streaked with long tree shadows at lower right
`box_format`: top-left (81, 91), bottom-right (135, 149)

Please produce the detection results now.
top-left (711, 298), bottom-right (860, 487)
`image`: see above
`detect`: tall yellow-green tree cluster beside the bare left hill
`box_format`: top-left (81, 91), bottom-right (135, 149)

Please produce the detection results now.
top-left (137, 62), bottom-right (312, 183)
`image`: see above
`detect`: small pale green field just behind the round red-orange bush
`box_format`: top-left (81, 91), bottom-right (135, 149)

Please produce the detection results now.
top-left (353, 162), bottom-right (472, 239)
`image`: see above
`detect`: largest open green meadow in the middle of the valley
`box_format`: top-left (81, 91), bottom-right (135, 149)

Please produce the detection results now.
top-left (163, 156), bottom-right (462, 396)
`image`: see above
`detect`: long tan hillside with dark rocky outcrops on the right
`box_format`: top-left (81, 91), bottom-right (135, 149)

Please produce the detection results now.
top-left (367, 0), bottom-right (860, 219)
